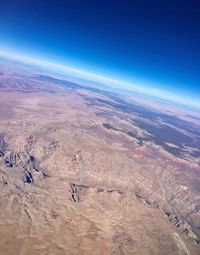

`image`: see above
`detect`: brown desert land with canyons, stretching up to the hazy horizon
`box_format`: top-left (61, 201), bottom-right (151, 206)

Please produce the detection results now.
top-left (0, 58), bottom-right (200, 255)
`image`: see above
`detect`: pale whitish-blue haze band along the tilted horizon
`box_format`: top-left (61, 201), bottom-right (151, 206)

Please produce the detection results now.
top-left (0, 48), bottom-right (200, 109)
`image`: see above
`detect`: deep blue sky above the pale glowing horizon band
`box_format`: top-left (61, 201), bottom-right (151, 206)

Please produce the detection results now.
top-left (0, 0), bottom-right (200, 97)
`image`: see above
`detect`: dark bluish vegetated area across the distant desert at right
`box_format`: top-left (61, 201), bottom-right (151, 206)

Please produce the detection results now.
top-left (37, 75), bottom-right (200, 157)
